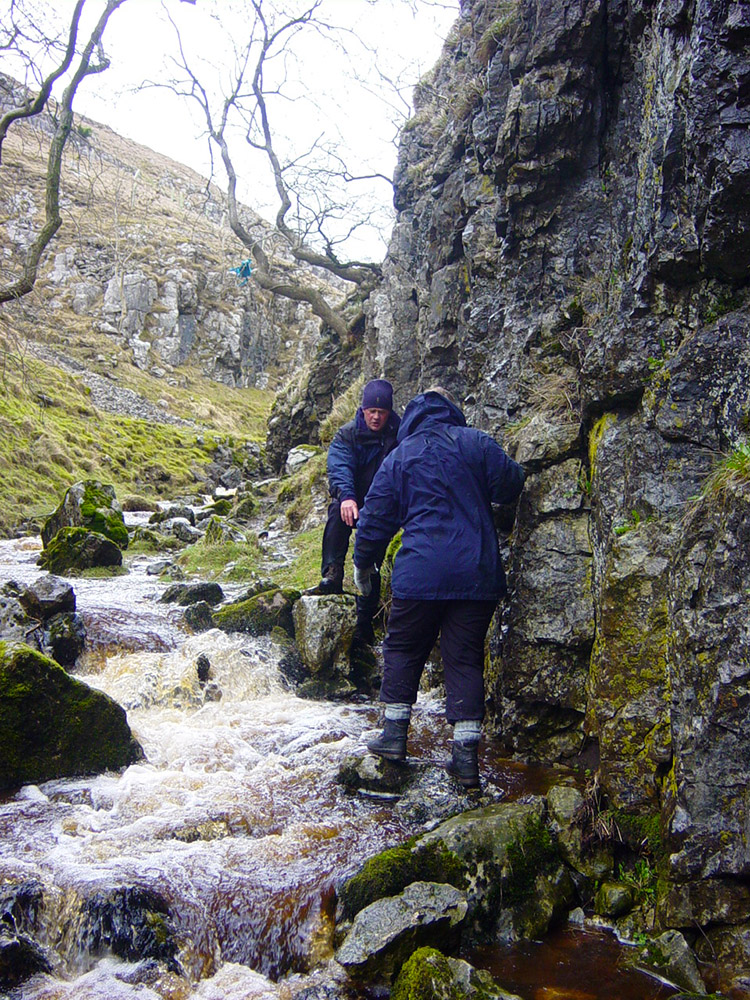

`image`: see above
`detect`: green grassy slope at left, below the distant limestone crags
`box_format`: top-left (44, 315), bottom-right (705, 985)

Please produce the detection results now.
top-left (0, 328), bottom-right (273, 534)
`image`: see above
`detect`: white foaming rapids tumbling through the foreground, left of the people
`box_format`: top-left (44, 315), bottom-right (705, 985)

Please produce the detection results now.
top-left (0, 631), bottom-right (408, 998)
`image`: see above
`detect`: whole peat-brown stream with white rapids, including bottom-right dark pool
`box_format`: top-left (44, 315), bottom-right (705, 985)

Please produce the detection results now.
top-left (0, 538), bottom-right (675, 1000)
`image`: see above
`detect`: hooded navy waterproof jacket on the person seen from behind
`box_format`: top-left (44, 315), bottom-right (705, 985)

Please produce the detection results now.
top-left (354, 392), bottom-right (524, 601)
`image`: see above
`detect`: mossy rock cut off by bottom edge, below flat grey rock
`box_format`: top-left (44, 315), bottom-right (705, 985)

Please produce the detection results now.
top-left (391, 948), bottom-right (520, 1000)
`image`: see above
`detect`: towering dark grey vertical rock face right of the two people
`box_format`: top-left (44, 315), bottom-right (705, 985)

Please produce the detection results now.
top-left (365, 0), bottom-right (750, 952)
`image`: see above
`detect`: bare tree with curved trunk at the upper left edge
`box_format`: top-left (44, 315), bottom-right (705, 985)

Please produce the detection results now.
top-left (0, 0), bottom-right (125, 303)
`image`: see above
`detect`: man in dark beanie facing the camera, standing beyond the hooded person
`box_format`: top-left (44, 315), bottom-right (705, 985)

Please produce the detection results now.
top-left (318, 379), bottom-right (400, 642)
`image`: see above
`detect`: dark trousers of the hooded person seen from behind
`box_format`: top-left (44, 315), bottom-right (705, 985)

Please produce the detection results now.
top-left (380, 597), bottom-right (497, 723)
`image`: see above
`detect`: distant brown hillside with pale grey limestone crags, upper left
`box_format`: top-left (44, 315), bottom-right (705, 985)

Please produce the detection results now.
top-left (0, 75), bottom-right (343, 388)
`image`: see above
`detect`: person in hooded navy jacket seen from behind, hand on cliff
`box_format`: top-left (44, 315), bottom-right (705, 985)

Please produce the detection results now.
top-left (354, 387), bottom-right (525, 788)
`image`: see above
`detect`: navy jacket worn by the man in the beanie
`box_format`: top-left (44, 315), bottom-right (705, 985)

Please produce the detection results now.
top-left (327, 406), bottom-right (401, 507)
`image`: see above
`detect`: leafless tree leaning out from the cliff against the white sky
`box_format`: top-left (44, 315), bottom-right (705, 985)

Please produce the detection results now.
top-left (162, 0), bottom-right (418, 340)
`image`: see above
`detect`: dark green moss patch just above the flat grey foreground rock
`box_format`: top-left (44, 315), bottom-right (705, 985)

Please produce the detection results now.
top-left (339, 841), bottom-right (466, 917)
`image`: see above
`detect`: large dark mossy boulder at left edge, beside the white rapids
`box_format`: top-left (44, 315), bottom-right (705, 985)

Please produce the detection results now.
top-left (0, 642), bottom-right (143, 788)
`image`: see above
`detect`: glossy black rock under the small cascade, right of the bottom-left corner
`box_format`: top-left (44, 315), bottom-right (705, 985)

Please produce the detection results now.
top-left (78, 886), bottom-right (178, 970)
